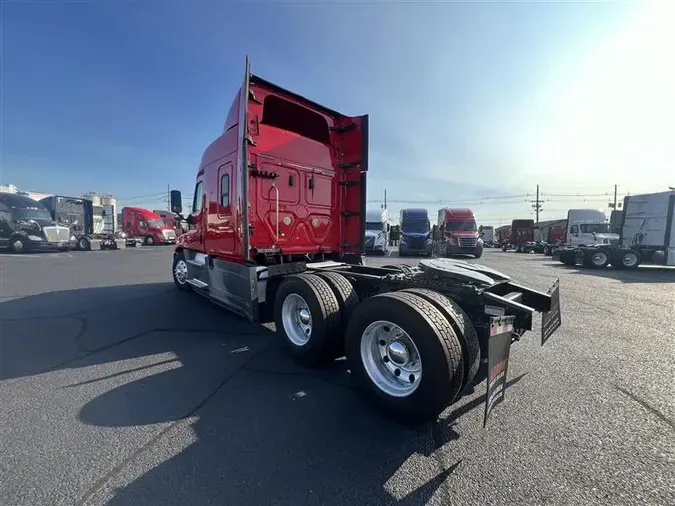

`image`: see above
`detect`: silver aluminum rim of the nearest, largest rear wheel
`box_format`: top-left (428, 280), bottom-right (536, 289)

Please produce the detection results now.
top-left (361, 320), bottom-right (422, 397)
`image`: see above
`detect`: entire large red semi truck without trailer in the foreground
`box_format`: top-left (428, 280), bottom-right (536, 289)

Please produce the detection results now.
top-left (166, 59), bottom-right (560, 423)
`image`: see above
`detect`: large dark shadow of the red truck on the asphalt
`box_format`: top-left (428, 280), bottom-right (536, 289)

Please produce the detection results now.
top-left (0, 283), bottom-right (502, 505)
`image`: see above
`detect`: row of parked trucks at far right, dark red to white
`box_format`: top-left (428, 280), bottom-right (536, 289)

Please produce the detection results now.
top-left (497, 190), bottom-right (675, 269)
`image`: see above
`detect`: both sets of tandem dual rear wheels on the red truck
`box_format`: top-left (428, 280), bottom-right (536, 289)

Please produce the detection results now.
top-left (274, 273), bottom-right (480, 424)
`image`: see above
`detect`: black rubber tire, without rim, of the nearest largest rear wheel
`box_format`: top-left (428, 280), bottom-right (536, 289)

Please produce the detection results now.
top-left (345, 292), bottom-right (464, 425)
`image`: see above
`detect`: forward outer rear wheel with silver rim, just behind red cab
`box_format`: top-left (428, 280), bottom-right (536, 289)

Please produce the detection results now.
top-left (274, 274), bottom-right (343, 366)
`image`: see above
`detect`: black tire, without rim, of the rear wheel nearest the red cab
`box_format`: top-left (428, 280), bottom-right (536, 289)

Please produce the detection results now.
top-left (274, 274), bottom-right (343, 366)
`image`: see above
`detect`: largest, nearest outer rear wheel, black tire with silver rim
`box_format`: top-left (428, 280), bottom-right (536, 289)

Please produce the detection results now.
top-left (345, 292), bottom-right (464, 424)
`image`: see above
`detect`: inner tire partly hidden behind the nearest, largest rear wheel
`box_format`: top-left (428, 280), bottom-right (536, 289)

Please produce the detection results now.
top-left (402, 288), bottom-right (480, 400)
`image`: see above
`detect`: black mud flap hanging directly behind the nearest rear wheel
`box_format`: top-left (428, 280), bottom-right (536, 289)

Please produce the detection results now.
top-left (483, 316), bottom-right (516, 427)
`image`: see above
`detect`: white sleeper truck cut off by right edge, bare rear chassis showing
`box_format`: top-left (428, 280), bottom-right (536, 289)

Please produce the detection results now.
top-left (559, 191), bottom-right (675, 269)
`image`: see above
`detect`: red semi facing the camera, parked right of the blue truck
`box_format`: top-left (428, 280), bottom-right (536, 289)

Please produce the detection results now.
top-left (434, 207), bottom-right (483, 258)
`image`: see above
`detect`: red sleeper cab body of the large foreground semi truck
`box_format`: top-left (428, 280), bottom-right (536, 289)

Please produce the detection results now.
top-left (180, 64), bottom-right (368, 263)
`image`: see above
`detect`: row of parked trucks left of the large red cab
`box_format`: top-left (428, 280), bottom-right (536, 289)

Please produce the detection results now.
top-left (0, 193), bottom-right (182, 253)
